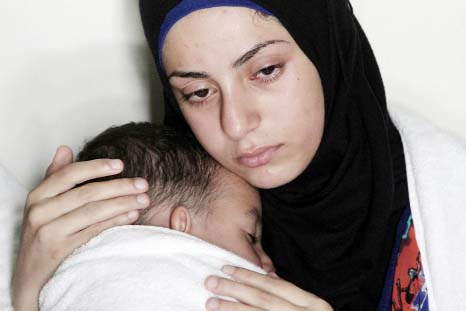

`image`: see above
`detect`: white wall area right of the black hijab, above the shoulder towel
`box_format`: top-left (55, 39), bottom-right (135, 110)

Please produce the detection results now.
top-left (352, 0), bottom-right (466, 138)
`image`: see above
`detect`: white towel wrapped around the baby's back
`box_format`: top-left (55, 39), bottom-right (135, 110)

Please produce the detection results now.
top-left (39, 226), bottom-right (265, 311)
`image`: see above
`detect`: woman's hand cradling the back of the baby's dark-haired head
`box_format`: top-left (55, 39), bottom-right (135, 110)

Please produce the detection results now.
top-left (13, 147), bottom-right (149, 311)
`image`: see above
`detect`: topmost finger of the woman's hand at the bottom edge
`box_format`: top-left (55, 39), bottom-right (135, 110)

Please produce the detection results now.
top-left (222, 266), bottom-right (320, 306)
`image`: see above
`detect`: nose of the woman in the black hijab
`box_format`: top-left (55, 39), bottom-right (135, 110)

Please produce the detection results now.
top-left (221, 92), bottom-right (261, 140)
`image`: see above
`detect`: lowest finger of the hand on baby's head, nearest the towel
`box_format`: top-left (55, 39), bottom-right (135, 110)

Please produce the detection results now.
top-left (71, 211), bottom-right (139, 249)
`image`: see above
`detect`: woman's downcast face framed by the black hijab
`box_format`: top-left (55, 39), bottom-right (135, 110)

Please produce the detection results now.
top-left (163, 7), bottom-right (324, 189)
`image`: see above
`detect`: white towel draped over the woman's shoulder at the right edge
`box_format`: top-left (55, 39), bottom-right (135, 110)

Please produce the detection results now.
top-left (390, 106), bottom-right (466, 310)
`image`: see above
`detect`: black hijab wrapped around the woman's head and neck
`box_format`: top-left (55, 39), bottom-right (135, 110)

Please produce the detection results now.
top-left (140, 0), bottom-right (409, 310)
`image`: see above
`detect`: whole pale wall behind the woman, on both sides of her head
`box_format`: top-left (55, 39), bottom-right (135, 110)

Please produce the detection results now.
top-left (0, 0), bottom-right (466, 188)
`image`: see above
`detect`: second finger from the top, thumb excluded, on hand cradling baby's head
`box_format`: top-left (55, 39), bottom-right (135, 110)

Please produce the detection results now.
top-left (30, 178), bottom-right (149, 226)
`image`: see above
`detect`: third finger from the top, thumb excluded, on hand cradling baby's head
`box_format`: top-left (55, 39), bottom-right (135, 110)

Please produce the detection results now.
top-left (50, 194), bottom-right (149, 235)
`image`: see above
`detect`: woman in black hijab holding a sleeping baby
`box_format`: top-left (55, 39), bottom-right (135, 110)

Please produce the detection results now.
top-left (14, 0), bottom-right (466, 310)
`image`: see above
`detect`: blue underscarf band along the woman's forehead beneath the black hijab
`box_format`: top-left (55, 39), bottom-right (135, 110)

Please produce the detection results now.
top-left (157, 0), bottom-right (273, 67)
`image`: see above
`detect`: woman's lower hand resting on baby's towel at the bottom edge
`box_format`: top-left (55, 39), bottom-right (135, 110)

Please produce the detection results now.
top-left (205, 266), bottom-right (333, 311)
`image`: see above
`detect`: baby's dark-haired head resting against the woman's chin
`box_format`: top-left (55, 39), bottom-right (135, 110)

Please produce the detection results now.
top-left (78, 122), bottom-right (273, 271)
